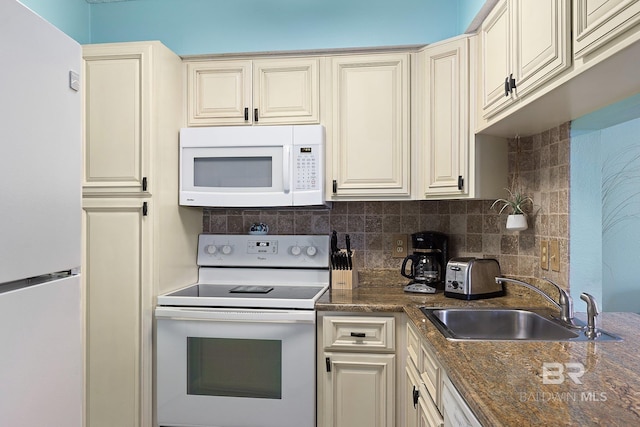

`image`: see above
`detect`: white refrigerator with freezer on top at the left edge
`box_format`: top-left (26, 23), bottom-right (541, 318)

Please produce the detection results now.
top-left (0, 0), bottom-right (83, 427)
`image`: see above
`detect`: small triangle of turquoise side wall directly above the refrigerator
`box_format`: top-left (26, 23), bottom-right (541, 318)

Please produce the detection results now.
top-left (20, 0), bottom-right (91, 44)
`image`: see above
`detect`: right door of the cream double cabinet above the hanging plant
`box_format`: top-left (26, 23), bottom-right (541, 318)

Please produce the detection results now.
top-left (512, 0), bottom-right (571, 96)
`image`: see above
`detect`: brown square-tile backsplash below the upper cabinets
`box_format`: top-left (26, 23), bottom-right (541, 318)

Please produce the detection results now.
top-left (203, 123), bottom-right (569, 286)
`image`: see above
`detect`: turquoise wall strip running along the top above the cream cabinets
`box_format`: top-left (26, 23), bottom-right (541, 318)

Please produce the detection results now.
top-left (22, 0), bottom-right (484, 55)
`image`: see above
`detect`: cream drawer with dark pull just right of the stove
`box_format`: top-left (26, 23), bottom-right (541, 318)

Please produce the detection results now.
top-left (322, 316), bottom-right (395, 351)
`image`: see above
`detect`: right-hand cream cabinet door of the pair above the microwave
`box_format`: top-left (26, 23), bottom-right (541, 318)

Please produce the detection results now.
top-left (253, 58), bottom-right (320, 124)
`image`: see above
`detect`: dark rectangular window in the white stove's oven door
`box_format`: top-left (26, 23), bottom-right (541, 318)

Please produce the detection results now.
top-left (187, 337), bottom-right (282, 399)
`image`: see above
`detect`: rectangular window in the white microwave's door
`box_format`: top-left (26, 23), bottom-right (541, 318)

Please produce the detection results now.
top-left (193, 156), bottom-right (273, 188)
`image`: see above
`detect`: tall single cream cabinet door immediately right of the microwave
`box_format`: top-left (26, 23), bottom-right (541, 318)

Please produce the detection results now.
top-left (327, 54), bottom-right (410, 200)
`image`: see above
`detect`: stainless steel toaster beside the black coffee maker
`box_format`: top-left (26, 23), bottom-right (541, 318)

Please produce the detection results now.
top-left (444, 258), bottom-right (504, 300)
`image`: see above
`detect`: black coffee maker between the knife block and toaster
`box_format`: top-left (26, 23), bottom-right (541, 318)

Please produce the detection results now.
top-left (400, 231), bottom-right (449, 294)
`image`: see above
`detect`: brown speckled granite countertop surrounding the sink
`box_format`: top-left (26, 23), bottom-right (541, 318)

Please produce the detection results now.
top-left (316, 272), bottom-right (640, 426)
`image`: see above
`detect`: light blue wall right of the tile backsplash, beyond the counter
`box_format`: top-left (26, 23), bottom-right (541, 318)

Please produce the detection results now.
top-left (569, 95), bottom-right (640, 313)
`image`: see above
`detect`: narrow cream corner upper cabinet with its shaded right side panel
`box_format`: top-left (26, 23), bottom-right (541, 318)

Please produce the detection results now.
top-left (412, 36), bottom-right (508, 199)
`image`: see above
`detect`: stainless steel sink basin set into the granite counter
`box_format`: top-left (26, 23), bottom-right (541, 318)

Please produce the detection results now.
top-left (420, 307), bottom-right (620, 341)
